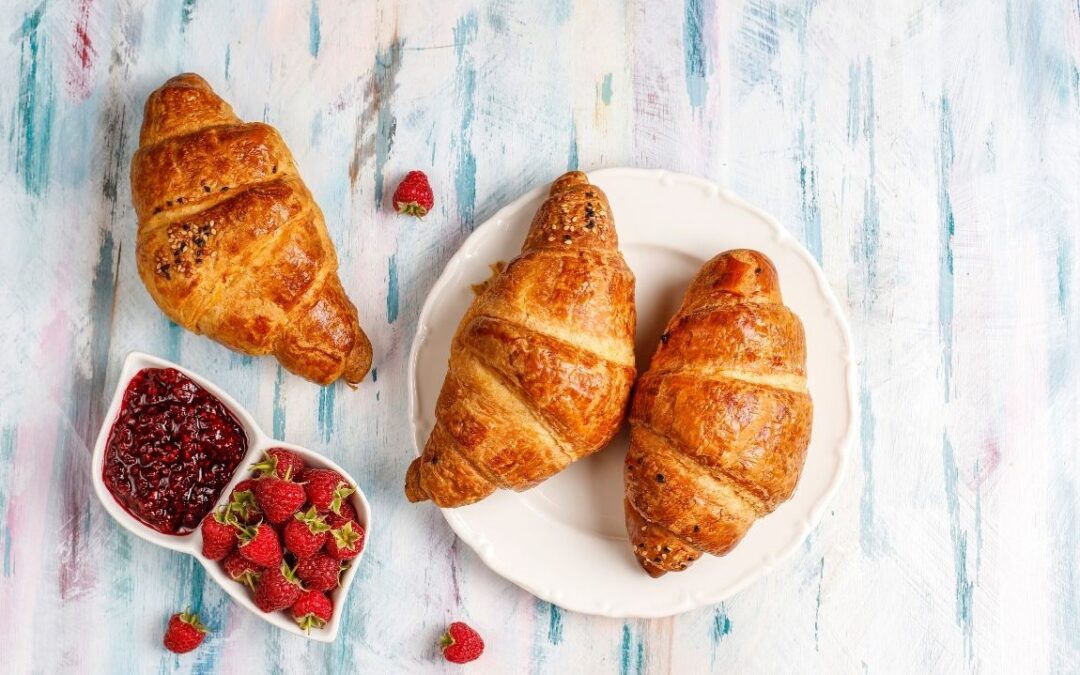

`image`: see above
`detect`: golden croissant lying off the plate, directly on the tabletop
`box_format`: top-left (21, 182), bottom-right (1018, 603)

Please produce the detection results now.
top-left (131, 73), bottom-right (372, 384)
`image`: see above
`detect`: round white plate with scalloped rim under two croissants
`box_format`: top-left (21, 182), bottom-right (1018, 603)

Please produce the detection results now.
top-left (409, 168), bottom-right (855, 618)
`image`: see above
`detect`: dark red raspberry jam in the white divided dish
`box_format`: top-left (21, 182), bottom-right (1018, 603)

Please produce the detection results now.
top-left (103, 368), bottom-right (247, 535)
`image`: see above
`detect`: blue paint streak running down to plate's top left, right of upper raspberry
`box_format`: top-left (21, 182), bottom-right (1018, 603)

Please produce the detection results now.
top-left (454, 12), bottom-right (477, 231)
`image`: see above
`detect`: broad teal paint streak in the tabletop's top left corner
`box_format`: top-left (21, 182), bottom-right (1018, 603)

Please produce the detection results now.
top-left (15, 2), bottom-right (56, 195)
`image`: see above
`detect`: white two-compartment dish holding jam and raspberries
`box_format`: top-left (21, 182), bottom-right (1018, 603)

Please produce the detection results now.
top-left (91, 352), bottom-right (372, 643)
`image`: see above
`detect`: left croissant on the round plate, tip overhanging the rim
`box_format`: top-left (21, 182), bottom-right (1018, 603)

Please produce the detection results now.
top-left (405, 172), bottom-right (636, 508)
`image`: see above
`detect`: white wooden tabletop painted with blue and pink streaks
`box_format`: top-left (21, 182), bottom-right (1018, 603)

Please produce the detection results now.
top-left (0, 0), bottom-right (1080, 674)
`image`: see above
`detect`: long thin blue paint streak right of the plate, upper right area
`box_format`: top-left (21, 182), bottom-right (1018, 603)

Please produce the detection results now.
top-left (937, 96), bottom-right (956, 401)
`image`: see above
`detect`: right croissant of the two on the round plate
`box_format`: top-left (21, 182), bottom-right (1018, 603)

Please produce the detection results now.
top-left (624, 249), bottom-right (812, 577)
